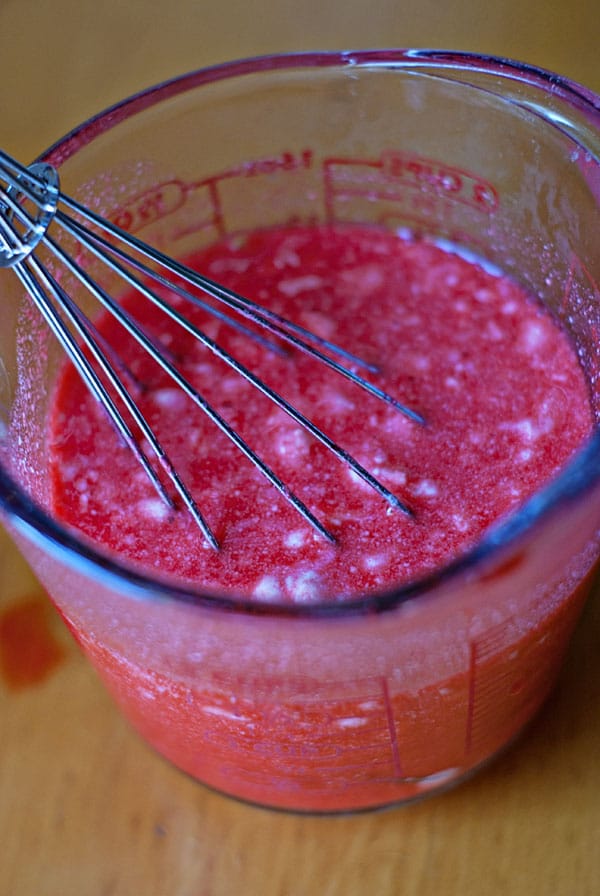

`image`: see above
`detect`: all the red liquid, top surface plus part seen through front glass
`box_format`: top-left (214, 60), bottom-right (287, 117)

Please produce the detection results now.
top-left (47, 227), bottom-right (592, 809)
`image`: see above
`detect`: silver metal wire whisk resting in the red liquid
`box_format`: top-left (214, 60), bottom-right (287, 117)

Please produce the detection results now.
top-left (0, 151), bottom-right (424, 549)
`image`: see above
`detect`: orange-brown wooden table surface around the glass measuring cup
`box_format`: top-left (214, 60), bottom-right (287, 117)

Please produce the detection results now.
top-left (0, 0), bottom-right (600, 896)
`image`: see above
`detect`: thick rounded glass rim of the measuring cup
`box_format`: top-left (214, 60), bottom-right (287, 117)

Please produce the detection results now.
top-left (0, 49), bottom-right (600, 619)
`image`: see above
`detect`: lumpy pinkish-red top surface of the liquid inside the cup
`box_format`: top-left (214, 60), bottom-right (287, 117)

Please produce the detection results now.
top-left (51, 226), bottom-right (591, 603)
